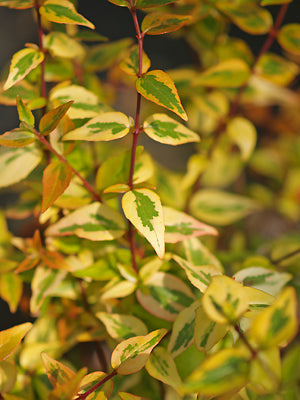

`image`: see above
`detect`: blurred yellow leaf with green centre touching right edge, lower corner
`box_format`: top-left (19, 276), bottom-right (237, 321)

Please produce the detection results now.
top-left (248, 287), bottom-right (298, 349)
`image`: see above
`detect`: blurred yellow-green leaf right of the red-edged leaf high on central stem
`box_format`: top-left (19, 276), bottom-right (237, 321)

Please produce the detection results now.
top-left (193, 58), bottom-right (251, 88)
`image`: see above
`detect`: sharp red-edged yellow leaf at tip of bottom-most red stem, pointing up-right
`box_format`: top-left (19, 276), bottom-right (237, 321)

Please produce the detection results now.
top-left (111, 329), bottom-right (167, 375)
